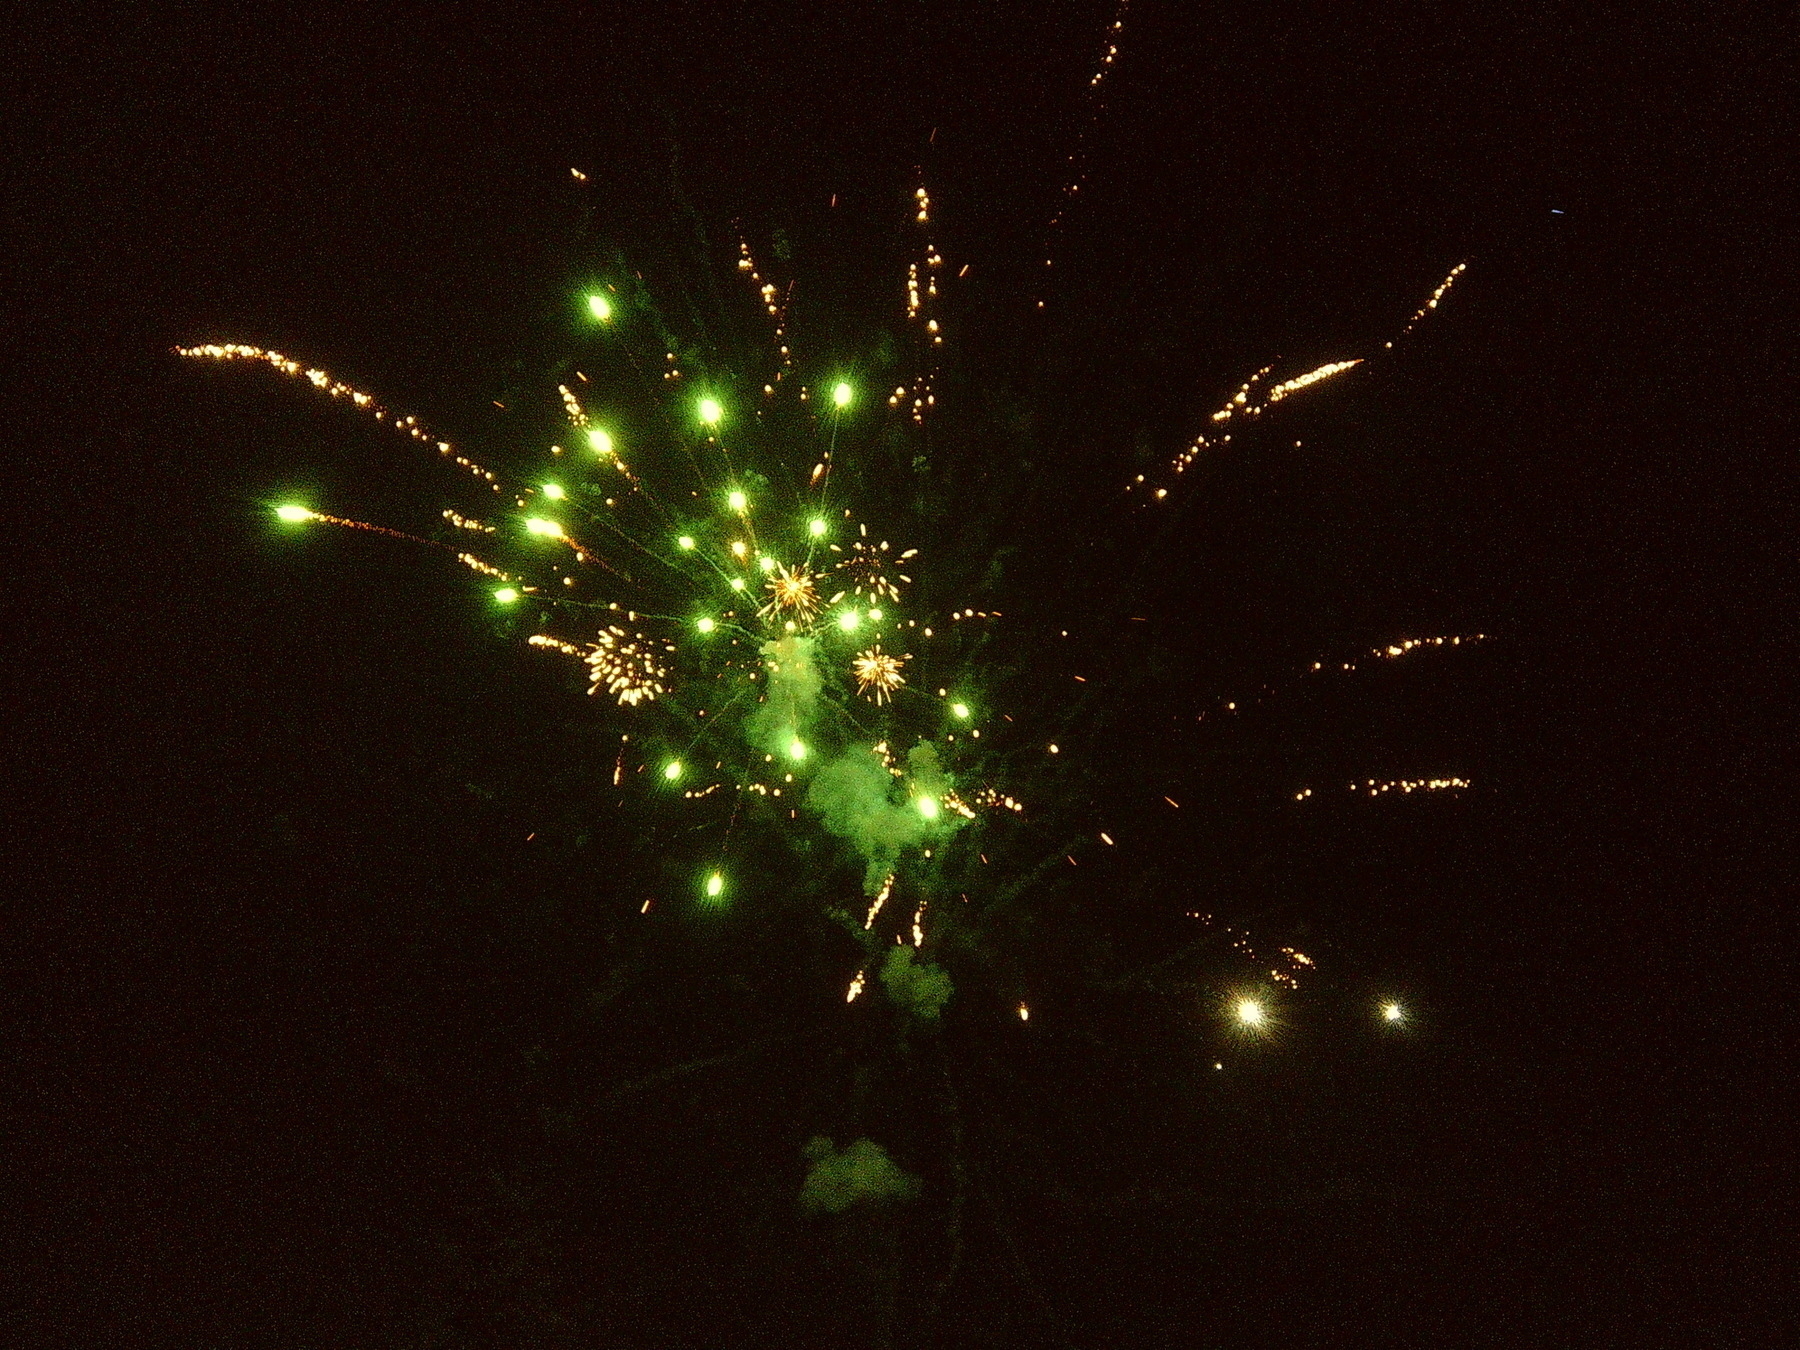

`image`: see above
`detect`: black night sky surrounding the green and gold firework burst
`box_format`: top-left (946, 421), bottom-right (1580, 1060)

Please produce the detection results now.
top-left (10, 0), bottom-right (1795, 1348)
